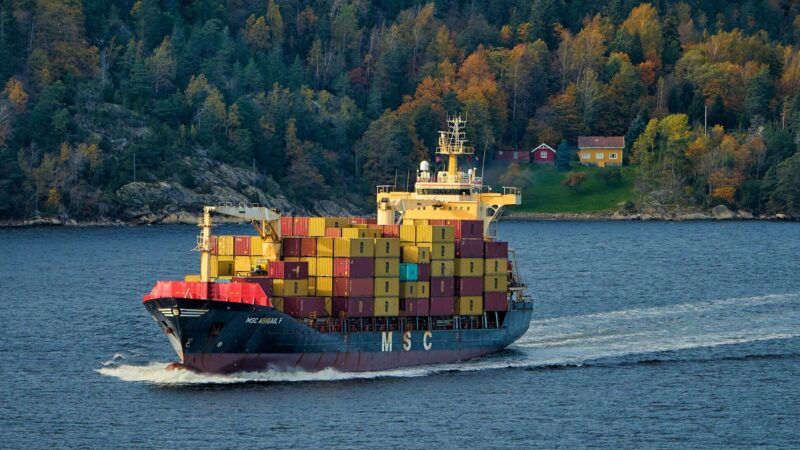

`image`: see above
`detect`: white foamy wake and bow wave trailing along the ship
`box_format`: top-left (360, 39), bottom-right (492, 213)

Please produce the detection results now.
top-left (97, 293), bottom-right (800, 385)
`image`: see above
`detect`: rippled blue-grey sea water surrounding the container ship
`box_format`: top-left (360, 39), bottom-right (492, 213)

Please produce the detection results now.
top-left (0, 222), bottom-right (800, 449)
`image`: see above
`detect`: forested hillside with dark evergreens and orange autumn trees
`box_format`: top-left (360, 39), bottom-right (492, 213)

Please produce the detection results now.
top-left (0, 0), bottom-right (800, 220)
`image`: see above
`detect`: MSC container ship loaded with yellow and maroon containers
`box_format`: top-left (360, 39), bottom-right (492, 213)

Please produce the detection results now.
top-left (144, 118), bottom-right (533, 373)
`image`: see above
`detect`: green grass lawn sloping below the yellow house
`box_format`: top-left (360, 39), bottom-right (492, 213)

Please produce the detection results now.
top-left (509, 164), bottom-right (635, 213)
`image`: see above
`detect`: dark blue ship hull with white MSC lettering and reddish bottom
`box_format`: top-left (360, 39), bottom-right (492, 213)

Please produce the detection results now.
top-left (145, 298), bottom-right (532, 373)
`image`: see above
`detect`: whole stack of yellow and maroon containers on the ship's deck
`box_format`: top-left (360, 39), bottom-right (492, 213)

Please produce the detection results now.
top-left (203, 217), bottom-right (509, 318)
